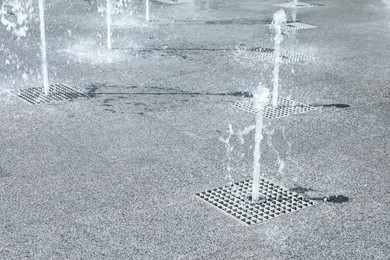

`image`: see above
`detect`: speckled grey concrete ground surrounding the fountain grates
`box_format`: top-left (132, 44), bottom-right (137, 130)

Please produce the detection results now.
top-left (0, 0), bottom-right (390, 259)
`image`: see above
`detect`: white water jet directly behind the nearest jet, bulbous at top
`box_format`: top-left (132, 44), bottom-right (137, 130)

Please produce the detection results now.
top-left (272, 10), bottom-right (287, 108)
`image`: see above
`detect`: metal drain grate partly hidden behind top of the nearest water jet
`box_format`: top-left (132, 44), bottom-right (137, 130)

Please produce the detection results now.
top-left (233, 97), bottom-right (316, 119)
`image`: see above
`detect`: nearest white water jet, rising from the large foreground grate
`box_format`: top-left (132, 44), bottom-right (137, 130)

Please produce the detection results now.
top-left (252, 85), bottom-right (270, 202)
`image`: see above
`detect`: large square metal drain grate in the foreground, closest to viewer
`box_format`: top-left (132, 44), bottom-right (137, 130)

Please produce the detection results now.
top-left (196, 179), bottom-right (314, 225)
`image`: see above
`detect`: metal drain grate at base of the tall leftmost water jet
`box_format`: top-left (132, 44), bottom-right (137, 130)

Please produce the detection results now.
top-left (13, 84), bottom-right (87, 105)
